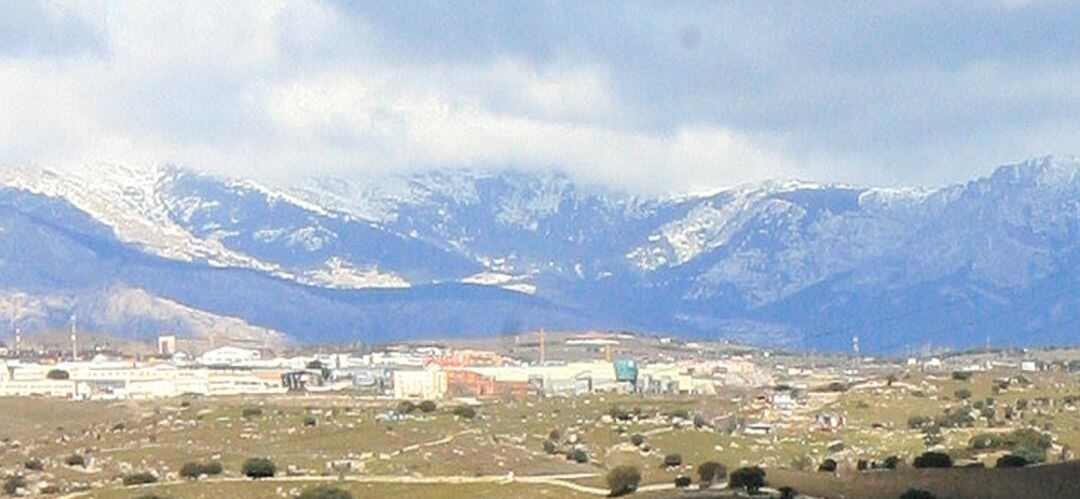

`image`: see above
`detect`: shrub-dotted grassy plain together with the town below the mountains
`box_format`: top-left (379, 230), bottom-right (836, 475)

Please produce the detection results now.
top-left (0, 329), bottom-right (1080, 498)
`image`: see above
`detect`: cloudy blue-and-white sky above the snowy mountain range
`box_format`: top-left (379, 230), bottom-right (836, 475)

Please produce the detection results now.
top-left (0, 0), bottom-right (1080, 192)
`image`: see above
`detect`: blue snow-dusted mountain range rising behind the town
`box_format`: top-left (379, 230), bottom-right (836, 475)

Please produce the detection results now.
top-left (0, 158), bottom-right (1080, 352)
